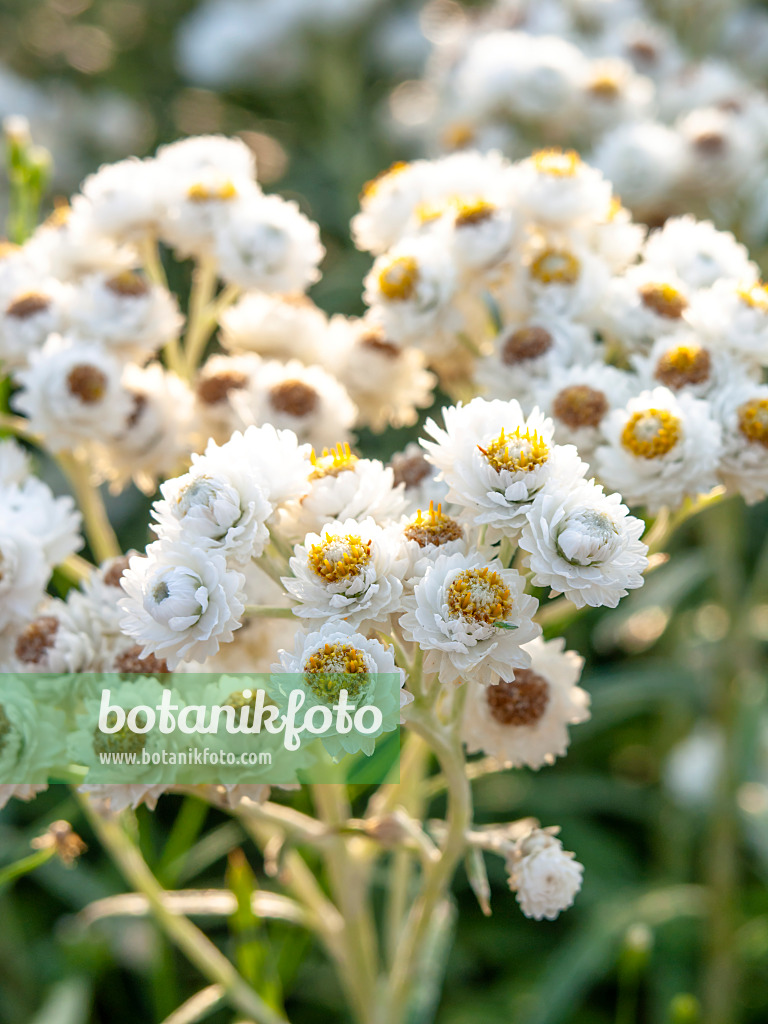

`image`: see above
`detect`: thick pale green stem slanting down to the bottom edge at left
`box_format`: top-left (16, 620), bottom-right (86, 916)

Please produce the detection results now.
top-left (79, 797), bottom-right (286, 1024)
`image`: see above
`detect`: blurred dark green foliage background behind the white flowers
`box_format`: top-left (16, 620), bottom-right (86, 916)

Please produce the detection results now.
top-left (0, 0), bottom-right (768, 1024)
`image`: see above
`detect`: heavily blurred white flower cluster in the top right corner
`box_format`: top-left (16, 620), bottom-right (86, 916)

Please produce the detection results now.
top-left (393, 0), bottom-right (768, 242)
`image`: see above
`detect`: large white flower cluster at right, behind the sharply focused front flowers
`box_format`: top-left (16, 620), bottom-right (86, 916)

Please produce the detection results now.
top-left (353, 150), bottom-right (768, 509)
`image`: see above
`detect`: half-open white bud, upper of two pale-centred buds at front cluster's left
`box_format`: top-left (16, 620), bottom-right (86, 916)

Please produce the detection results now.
top-left (153, 457), bottom-right (272, 563)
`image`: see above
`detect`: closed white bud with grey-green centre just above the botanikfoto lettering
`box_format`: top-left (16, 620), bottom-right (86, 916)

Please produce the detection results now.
top-left (120, 541), bottom-right (244, 670)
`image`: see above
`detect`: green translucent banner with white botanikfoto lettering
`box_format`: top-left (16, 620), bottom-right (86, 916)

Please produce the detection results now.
top-left (0, 673), bottom-right (400, 785)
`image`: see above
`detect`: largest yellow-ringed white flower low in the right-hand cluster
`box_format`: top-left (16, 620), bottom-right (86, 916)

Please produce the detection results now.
top-left (596, 387), bottom-right (722, 513)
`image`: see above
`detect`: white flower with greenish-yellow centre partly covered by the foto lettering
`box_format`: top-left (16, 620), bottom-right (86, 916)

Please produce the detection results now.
top-left (269, 623), bottom-right (413, 757)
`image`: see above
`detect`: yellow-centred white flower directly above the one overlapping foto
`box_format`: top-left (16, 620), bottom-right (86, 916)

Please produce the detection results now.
top-left (283, 519), bottom-right (406, 630)
